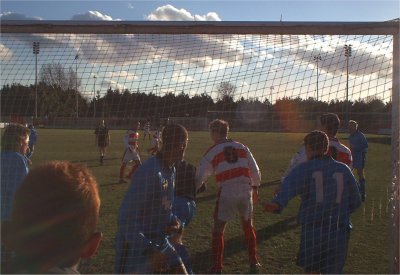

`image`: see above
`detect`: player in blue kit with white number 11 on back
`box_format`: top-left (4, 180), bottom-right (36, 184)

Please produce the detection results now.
top-left (264, 131), bottom-right (361, 274)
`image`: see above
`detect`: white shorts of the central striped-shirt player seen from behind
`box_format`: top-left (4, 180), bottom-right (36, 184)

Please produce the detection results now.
top-left (214, 189), bottom-right (253, 222)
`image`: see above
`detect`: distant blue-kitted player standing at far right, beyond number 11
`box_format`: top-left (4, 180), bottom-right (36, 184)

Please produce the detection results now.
top-left (348, 120), bottom-right (368, 201)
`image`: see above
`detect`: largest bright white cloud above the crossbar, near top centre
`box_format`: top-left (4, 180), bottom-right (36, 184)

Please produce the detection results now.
top-left (147, 5), bottom-right (221, 21)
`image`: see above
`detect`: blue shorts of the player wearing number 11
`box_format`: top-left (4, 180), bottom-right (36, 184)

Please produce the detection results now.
top-left (297, 222), bottom-right (350, 274)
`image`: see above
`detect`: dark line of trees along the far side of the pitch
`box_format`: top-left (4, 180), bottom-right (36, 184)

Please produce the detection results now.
top-left (0, 64), bottom-right (392, 131)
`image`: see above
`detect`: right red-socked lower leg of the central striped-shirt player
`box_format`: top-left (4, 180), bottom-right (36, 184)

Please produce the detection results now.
top-left (241, 217), bottom-right (261, 274)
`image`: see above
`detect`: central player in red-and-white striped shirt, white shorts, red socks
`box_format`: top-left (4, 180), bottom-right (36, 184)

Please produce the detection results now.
top-left (196, 119), bottom-right (261, 273)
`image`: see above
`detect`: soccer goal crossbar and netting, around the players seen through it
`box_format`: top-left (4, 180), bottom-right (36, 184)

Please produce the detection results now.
top-left (0, 21), bottom-right (399, 273)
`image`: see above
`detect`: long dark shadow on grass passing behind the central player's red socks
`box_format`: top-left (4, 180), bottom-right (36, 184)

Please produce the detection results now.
top-left (191, 216), bottom-right (299, 274)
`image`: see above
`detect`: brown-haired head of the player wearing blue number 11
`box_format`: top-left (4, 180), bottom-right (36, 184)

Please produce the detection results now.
top-left (304, 131), bottom-right (329, 159)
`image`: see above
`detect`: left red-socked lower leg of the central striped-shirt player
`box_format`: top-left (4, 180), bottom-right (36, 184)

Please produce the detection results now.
top-left (210, 219), bottom-right (226, 274)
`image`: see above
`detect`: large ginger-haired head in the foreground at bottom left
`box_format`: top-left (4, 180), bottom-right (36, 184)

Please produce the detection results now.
top-left (6, 161), bottom-right (101, 273)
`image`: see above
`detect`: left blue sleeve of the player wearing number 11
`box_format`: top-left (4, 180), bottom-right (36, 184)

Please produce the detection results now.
top-left (272, 164), bottom-right (305, 210)
